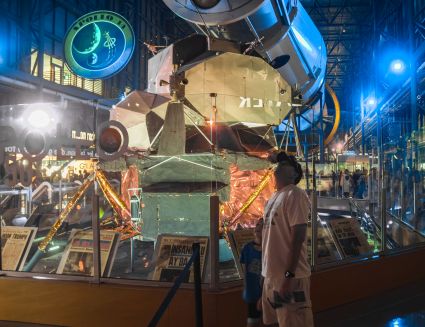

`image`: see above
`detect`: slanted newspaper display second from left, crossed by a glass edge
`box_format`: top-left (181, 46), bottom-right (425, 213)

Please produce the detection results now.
top-left (57, 229), bottom-right (120, 277)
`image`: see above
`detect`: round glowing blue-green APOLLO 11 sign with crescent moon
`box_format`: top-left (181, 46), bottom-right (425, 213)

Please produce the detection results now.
top-left (64, 10), bottom-right (135, 79)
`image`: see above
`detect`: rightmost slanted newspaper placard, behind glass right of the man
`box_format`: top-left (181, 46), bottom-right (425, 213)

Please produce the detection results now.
top-left (329, 218), bottom-right (372, 257)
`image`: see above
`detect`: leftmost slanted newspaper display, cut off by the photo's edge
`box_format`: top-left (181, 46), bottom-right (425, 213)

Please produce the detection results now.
top-left (1, 226), bottom-right (37, 271)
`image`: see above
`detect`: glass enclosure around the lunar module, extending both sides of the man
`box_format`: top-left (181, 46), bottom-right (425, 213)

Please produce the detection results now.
top-left (0, 98), bottom-right (425, 288)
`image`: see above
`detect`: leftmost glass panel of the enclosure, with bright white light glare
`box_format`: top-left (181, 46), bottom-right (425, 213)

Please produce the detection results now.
top-left (0, 103), bottom-right (97, 276)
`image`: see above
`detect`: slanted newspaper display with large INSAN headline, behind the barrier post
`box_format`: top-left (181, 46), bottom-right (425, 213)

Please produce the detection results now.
top-left (152, 235), bottom-right (208, 283)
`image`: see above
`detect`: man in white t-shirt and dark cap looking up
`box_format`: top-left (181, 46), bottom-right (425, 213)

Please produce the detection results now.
top-left (262, 153), bottom-right (313, 327)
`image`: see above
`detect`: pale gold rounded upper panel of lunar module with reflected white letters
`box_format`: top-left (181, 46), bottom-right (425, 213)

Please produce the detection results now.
top-left (185, 53), bottom-right (291, 125)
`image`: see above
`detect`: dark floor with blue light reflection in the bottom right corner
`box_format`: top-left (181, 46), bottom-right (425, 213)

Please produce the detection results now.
top-left (315, 280), bottom-right (425, 327)
